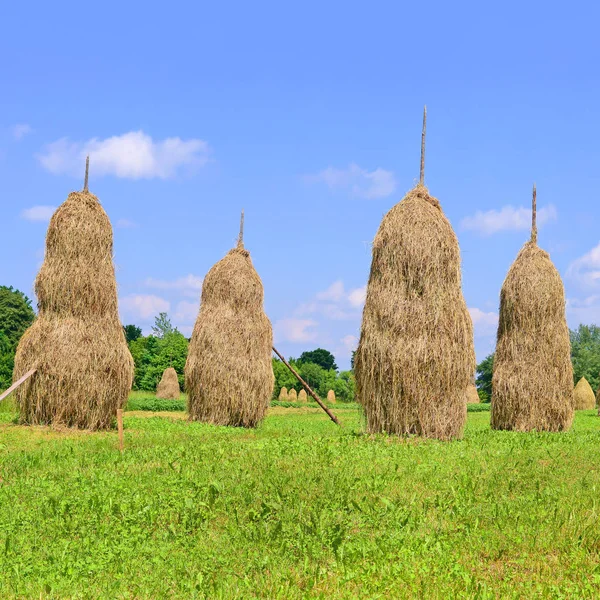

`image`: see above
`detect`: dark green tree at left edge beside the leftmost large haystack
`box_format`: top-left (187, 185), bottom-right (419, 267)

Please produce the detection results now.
top-left (0, 286), bottom-right (35, 390)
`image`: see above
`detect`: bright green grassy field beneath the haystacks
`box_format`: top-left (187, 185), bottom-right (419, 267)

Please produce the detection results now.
top-left (0, 398), bottom-right (600, 599)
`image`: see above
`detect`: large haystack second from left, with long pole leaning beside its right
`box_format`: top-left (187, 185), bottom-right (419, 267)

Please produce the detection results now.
top-left (185, 213), bottom-right (274, 427)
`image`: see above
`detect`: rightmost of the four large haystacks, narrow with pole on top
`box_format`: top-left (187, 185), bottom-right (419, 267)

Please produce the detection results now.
top-left (491, 186), bottom-right (573, 431)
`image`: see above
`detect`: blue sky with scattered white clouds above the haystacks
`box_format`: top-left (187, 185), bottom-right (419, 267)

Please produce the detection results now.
top-left (0, 1), bottom-right (600, 367)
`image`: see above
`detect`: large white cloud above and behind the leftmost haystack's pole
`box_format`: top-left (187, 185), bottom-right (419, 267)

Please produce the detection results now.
top-left (38, 131), bottom-right (210, 179)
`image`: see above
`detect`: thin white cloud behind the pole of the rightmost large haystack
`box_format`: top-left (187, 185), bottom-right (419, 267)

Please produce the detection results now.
top-left (461, 204), bottom-right (557, 236)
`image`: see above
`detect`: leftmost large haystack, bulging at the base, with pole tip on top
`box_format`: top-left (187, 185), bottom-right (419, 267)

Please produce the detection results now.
top-left (13, 158), bottom-right (133, 429)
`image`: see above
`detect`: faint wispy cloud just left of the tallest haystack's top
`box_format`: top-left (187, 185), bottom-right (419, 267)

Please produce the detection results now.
top-left (305, 163), bottom-right (396, 200)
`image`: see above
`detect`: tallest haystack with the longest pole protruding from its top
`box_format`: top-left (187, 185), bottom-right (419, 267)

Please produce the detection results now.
top-left (355, 108), bottom-right (475, 440)
